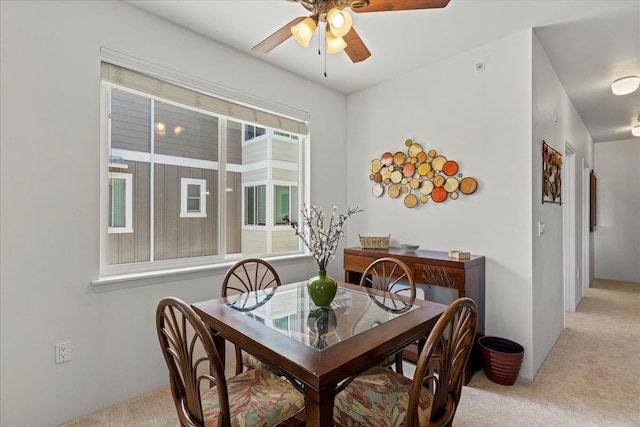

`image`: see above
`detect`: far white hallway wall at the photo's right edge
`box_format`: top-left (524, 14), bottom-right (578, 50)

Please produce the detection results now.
top-left (592, 138), bottom-right (640, 282)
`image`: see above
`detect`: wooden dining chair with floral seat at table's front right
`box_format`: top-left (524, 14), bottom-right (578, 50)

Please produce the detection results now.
top-left (333, 298), bottom-right (478, 427)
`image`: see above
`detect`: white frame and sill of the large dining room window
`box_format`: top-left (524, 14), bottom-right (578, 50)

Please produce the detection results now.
top-left (97, 48), bottom-right (310, 280)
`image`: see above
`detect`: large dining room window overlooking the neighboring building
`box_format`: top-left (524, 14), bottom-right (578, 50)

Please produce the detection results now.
top-left (101, 63), bottom-right (306, 275)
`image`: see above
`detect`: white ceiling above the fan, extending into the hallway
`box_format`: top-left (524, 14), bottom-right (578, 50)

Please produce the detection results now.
top-left (128, 0), bottom-right (640, 142)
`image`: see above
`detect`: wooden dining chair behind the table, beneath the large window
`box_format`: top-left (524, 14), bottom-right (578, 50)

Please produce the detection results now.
top-left (221, 258), bottom-right (281, 374)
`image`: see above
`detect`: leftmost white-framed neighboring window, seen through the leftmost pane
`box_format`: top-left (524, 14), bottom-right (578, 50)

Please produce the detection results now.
top-left (108, 172), bottom-right (133, 233)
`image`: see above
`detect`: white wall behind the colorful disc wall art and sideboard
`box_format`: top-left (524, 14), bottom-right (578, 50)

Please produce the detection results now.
top-left (347, 31), bottom-right (537, 379)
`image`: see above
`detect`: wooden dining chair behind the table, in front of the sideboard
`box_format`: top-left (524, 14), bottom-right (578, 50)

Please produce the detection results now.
top-left (360, 257), bottom-right (416, 374)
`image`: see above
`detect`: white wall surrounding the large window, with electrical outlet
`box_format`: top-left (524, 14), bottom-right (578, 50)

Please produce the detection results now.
top-left (0, 1), bottom-right (347, 426)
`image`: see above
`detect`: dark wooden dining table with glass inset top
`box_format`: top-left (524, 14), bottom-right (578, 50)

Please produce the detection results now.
top-left (192, 282), bottom-right (446, 426)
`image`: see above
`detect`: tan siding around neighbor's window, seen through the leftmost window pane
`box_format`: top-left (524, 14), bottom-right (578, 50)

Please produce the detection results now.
top-left (107, 161), bottom-right (150, 264)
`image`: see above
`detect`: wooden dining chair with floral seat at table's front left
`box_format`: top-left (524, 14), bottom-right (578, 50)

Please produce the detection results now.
top-left (156, 297), bottom-right (304, 427)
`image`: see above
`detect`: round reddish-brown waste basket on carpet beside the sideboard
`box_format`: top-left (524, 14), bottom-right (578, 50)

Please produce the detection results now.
top-left (478, 336), bottom-right (524, 385)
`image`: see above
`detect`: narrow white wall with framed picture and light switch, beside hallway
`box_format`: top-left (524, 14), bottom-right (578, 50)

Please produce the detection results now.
top-left (532, 35), bottom-right (593, 371)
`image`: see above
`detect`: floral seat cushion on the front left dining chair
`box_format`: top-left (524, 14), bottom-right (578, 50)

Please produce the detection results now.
top-left (202, 369), bottom-right (305, 427)
